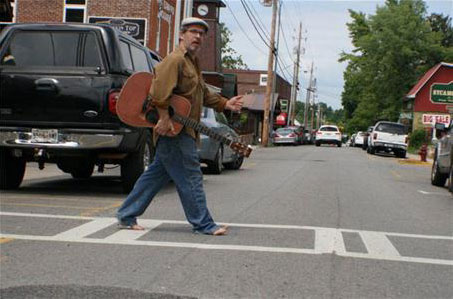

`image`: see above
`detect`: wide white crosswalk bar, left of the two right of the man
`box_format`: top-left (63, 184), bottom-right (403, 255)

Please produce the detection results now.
top-left (315, 228), bottom-right (346, 253)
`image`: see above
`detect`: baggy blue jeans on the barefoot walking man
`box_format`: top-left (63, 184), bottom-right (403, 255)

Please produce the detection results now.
top-left (117, 132), bottom-right (219, 234)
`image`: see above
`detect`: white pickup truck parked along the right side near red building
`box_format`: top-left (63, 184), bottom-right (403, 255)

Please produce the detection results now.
top-left (367, 121), bottom-right (408, 158)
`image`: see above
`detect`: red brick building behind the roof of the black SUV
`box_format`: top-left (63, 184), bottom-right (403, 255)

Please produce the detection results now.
top-left (2, 0), bottom-right (176, 56)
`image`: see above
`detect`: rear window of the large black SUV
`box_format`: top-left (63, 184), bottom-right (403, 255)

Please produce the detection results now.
top-left (1, 31), bottom-right (101, 67)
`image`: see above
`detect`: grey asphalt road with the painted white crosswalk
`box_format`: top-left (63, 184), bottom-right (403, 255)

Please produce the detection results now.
top-left (0, 146), bottom-right (453, 298)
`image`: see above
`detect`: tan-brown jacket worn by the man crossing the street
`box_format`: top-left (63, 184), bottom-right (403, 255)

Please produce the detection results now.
top-left (150, 44), bottom-right (227, 140)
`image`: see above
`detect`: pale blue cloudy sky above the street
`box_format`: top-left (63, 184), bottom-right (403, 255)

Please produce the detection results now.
top-left (220, 0), bottom-right (453, 109)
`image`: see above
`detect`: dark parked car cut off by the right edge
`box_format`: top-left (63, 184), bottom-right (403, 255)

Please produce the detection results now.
top-left (431, 121), bottom-right (453, 192)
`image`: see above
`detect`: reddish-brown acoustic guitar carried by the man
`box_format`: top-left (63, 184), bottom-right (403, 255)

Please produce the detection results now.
top-left (116, 72), bottom-right (252, 157)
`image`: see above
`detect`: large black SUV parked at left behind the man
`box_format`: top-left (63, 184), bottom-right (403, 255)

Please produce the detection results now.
top-left (0, 24), bottom-right (160, 192)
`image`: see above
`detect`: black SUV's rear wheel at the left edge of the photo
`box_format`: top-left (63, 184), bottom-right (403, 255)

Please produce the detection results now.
top-left (0, 150), bottom-right (26, 190)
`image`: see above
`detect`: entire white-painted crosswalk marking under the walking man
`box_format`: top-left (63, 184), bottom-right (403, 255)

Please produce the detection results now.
top-left (0, 212), bottom-right (453, 265)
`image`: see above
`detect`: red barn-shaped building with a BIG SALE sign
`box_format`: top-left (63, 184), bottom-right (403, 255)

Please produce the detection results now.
top-left (400, 62), bottom-right (453, 130)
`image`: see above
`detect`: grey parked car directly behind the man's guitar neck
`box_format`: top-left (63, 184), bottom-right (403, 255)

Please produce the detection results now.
top-left (198, 107), bottom-right (244, 174)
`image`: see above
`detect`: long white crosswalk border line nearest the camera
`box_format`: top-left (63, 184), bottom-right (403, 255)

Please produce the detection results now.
top-left (0, 234), bottom-right (453, 266)
